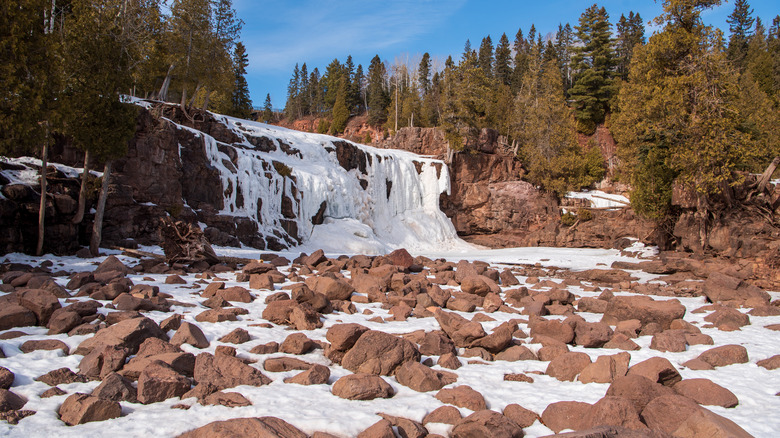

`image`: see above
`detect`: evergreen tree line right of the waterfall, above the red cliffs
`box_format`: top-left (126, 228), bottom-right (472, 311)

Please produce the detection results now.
top-left (285, 0), bottom-right (780, 236)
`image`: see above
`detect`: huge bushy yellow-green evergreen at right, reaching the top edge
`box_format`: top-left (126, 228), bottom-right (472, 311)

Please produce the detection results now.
top-left (612, 0), bottom-right (757, 247)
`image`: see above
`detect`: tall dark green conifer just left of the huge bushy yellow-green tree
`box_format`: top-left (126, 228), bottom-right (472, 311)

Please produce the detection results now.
top-left (569, 5), bottom-right (616, 133)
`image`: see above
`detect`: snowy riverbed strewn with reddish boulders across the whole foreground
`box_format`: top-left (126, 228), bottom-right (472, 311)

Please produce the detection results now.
top-left (0, 245), bottom-right (780, 437)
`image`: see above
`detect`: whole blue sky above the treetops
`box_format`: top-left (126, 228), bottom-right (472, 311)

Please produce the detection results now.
top-left (233, 0), bottom-right (780, 108)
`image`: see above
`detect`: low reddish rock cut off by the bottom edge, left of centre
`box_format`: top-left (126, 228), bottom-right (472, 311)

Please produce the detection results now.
top-left (178, 417), bottom-right (307, 438)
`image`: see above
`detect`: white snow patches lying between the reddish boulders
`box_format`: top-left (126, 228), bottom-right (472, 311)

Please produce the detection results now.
top-left (0, 243), bottom-right (780, 438)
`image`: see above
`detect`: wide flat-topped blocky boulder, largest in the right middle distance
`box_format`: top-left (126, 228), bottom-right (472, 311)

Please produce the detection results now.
top-left (601, 295), bottom-right (685, 330)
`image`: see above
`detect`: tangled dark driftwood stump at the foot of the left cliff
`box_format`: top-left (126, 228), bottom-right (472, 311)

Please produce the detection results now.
top-left (160, 218), bottom-right (219, 265)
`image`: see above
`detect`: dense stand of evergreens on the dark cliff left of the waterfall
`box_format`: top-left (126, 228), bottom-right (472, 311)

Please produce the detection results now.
top-left (0, 0), bottom-right (252, 254)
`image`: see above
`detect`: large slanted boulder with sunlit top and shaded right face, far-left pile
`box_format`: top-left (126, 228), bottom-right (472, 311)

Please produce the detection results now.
top-left (73, 317), bottom-right (168, 354)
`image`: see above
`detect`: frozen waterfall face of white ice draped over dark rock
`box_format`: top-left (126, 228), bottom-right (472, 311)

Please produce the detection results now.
top-left (193, 116), bottom-right (462, 254)
